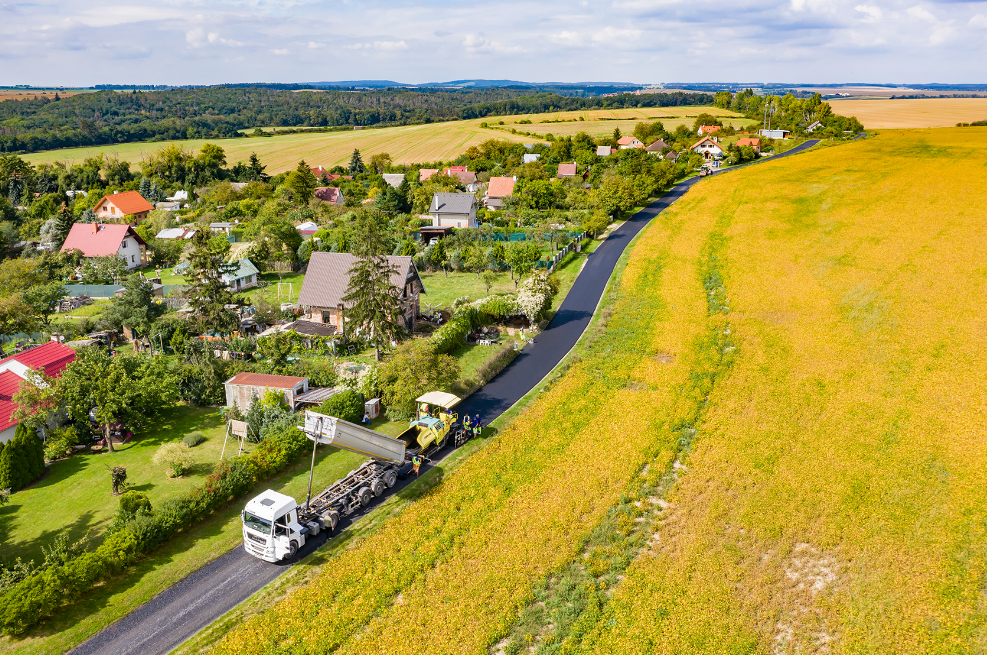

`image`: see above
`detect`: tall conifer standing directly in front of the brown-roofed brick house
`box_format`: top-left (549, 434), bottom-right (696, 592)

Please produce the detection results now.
top-left (343, 211), bottom-right (404, 361)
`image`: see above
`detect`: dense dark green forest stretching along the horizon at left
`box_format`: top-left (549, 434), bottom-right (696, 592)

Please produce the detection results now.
top-left (0, 86), bottom-right (713, 153)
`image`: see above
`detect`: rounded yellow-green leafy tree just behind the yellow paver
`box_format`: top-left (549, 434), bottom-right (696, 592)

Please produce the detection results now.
top-left (378, 339), bottom-right (460, 419)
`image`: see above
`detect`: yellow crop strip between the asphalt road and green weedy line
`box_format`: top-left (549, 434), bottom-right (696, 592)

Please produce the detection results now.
top-left (208, 182), bottom-right (712, 653)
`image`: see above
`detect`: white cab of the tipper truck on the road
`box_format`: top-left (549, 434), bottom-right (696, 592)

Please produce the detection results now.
top-left (241, 489), bottom-right (310, 562)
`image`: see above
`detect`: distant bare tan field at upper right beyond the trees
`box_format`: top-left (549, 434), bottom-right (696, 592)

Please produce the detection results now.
top-left (830, 98), bottom-right (987, 130)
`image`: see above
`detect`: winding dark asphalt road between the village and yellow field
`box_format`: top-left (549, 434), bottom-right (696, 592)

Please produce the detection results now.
top-left (71, 141), bottom-right (818, 655)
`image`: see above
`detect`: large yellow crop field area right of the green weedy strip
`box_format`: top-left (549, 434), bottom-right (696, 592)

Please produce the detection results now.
top-left (556, 128), bottom-right (987, 654)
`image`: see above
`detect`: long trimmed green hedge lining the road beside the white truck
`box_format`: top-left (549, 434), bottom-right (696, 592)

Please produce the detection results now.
top-left (0, 428), bottom-right (308, 635)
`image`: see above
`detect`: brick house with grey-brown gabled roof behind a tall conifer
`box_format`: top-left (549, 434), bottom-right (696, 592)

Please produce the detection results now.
top-left (298, 252), bottom-right (425, 333)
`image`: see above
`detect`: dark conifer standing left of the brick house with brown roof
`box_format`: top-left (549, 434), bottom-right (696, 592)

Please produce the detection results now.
top-left (185, 230), bottom-right (239, 334)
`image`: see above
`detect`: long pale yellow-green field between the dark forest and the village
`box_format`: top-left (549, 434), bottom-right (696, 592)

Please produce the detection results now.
top-left (24, 106), bottom-right (736, 174)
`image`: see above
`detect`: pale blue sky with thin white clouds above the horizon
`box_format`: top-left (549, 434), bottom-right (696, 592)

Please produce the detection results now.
top-left (0, 0), bottom-right (987, 86)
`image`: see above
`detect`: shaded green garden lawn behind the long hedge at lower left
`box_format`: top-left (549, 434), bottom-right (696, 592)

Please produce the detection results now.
top-left (0, 405), bottom-right (225, 562)
